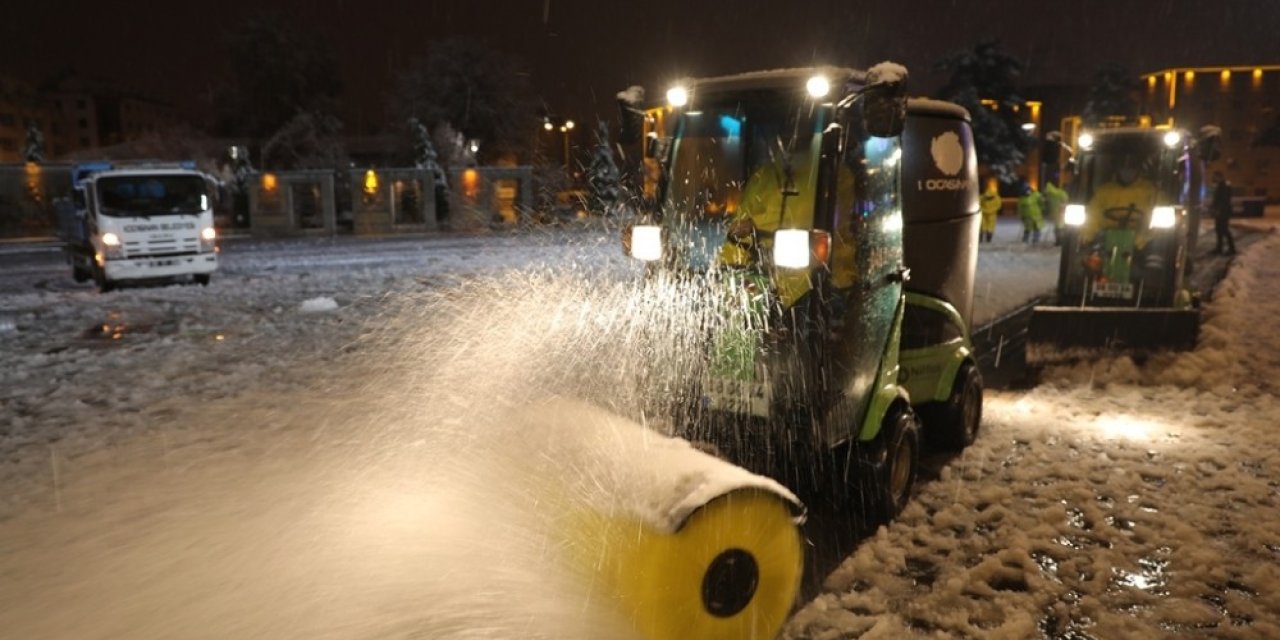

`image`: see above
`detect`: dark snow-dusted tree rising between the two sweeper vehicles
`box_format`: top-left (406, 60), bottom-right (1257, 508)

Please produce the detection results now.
top-left (934, 41), bottom-right (1032, 183)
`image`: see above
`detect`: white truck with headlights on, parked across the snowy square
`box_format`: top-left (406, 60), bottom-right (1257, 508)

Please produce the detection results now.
top-left (58, 163), bottom-right (218, 292)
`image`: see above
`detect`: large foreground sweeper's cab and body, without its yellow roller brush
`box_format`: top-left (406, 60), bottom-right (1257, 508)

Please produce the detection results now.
top-left (618, 63), bottom-right (982, 517)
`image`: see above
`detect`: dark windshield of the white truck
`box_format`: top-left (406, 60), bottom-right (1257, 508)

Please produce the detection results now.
top-left (97, 175), bottom-right (209, 216)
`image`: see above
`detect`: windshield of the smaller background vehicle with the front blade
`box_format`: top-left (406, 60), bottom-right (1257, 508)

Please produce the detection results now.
top-left (1075, 134), bottom-right (1185, 205)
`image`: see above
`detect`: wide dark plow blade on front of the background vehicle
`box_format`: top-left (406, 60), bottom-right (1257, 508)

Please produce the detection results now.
top-left (1027, 307), bottom-right (1199, 365)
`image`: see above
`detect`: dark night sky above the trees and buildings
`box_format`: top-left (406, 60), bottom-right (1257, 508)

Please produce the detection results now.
top-left (0, 0), bottom-right (1280, 131)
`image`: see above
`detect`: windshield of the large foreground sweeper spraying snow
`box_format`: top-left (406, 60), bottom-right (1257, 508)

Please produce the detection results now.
top-left (663, 92), bottom-right (829, 268)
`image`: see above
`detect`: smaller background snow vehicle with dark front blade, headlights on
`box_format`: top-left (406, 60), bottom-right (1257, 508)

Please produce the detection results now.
top-left (1027, 127), bottom-right (1203, 355)
